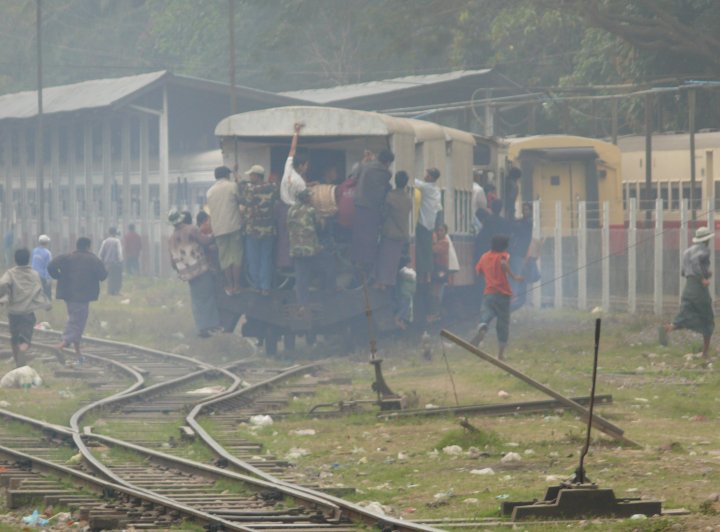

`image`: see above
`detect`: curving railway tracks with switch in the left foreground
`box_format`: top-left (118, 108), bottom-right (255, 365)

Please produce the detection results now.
top-left (0, 326), bottom-right (433, 532)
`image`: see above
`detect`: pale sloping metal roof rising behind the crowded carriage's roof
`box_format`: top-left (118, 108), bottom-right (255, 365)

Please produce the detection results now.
top-left (280, 68), bottom-right (491, 104)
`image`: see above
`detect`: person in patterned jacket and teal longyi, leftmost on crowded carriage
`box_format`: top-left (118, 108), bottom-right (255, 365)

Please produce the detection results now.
top-left (168, 209), bottom-right (220, 338)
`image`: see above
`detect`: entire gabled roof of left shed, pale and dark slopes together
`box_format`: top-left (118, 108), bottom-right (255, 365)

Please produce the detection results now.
top-left (0, 70), bottom-right (306, 120)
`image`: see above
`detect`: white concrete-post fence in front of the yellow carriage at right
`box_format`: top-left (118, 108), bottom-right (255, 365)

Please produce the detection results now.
top-left (529, 199), bottom-right (720, 314)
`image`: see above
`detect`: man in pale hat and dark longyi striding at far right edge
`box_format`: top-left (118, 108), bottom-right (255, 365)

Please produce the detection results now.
top-left (658, 227), bottom-right (715, 358)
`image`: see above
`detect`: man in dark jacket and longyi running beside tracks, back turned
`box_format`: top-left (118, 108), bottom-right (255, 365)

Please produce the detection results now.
top-left (48, 236), bottom-right (108, 356)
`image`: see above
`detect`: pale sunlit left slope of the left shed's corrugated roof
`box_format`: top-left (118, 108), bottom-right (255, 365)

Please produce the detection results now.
top-left (0, 70), bottom-right (167, 120)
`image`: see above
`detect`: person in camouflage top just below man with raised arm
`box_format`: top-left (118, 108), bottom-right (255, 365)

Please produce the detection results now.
top-left (288, 189), bottom-right (336, 312)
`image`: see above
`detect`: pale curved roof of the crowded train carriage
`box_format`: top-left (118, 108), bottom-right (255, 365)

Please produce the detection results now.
top-left (215, 106), bottom-right (475, 145)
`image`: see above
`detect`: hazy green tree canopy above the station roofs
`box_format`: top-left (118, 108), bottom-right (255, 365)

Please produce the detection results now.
top-left (0, 0), bottom-right (720, 135)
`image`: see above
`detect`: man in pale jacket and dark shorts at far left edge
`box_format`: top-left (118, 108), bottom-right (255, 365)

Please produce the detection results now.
top-left (0, 248), bottom-right (52, 368)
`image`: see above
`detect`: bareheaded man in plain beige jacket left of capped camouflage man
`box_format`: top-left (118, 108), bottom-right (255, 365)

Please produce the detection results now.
top-left (207, 166), bottom-right (243, 295)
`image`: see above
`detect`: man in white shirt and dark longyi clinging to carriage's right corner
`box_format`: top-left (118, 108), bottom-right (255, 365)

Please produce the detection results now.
top-left (415, 168), bottom-right (442, 284)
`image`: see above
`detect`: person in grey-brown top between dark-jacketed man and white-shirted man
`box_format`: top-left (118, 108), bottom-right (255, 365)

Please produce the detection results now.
top-left (375, 170), bottom-right (412, 290)
